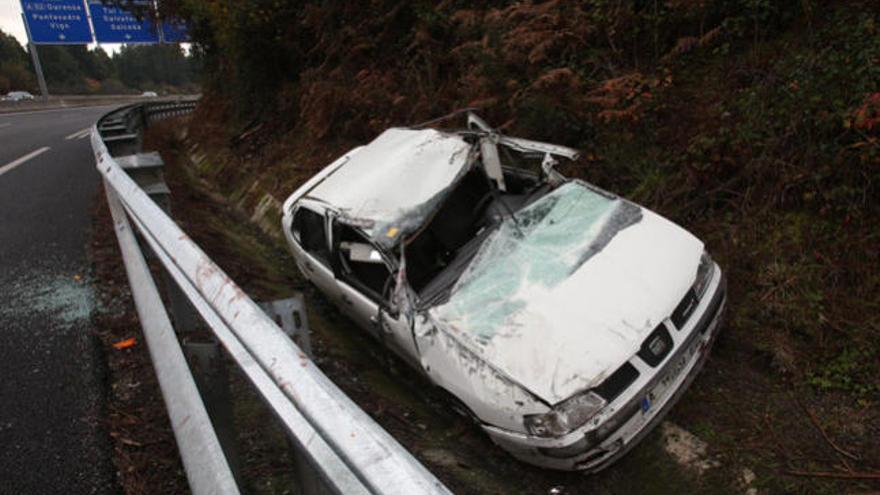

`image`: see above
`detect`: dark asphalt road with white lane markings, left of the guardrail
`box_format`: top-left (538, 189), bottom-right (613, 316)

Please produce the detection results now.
top-left (0, 107), bottom-right (119, 495)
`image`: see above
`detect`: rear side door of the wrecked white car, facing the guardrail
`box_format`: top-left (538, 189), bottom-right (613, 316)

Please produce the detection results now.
top-left (290, 203), bottom-right (339, 301)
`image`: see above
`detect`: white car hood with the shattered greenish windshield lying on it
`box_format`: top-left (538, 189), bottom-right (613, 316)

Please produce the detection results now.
top-left (429, 183), bottom-right (703, 404)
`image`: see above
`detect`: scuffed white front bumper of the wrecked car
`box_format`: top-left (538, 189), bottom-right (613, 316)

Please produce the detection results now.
top-left (484, 265), bottom-right (727, 472)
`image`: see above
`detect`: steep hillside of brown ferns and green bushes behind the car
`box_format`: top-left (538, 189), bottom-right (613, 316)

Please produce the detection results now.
top-left (155, 0), bottom-right (880, 492)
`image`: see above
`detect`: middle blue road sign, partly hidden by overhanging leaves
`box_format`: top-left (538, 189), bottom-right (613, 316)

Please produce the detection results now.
top-left (89, 0), bottom-right (159, 43)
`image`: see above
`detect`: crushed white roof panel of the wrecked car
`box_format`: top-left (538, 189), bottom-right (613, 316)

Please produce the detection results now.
top-left (309, 128), bottom-right (471, 246)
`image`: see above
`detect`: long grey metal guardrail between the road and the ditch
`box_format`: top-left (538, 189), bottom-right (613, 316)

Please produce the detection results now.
top-left (91, 100), bottom-right (450, 495)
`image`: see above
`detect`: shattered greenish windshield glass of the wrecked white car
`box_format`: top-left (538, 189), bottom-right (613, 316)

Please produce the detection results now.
top-left (434, 182), bottom-right (641, 341)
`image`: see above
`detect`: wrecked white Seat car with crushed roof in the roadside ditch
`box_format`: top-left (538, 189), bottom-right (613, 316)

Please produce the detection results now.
top-left (283, 115), bottom-right (726, 471)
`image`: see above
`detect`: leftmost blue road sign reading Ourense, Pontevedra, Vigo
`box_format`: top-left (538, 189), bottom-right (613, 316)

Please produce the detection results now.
top-left (21, 0), bottom-right (92, 45)
